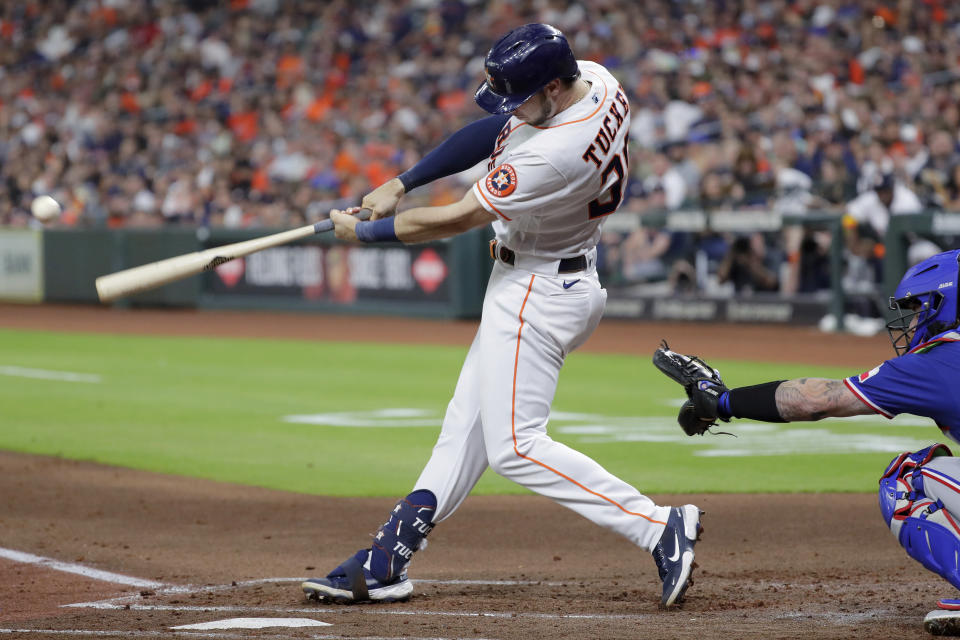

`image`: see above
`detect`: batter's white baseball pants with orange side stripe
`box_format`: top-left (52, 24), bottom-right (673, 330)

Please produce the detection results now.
top-left (414, 252), bottom-right (669, 551)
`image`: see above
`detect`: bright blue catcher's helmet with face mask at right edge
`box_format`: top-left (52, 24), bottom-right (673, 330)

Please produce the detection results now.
top-left (887, 249), bottom-right (960, 355)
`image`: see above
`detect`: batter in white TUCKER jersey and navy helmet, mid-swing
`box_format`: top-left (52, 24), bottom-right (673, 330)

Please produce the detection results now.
top-left (303, 24), bottom-right (701, 606)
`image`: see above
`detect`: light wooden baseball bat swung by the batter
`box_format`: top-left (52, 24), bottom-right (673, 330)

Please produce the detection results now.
top-left (96, 209), bottom-right (371, 302)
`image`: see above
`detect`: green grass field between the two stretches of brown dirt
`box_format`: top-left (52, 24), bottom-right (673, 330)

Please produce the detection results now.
top-left (0, 330), bottom-right (941, 496)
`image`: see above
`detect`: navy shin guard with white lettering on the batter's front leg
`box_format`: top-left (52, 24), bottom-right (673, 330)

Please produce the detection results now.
top-left (370, 490), bottom-right (437, 582)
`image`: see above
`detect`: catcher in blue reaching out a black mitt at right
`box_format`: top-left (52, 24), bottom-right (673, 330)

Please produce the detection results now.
top-left (653, 250), bottom-right (960, 633)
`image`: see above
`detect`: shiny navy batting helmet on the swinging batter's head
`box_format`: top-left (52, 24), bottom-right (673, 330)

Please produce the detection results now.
top-left (473, 23), bottom-right (580, 113)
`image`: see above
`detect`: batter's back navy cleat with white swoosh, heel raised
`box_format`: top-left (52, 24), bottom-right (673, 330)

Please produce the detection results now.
top-left (653, 504), bottom-right (703, 607)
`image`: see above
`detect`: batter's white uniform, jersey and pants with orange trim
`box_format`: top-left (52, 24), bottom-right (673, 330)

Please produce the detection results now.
top-left (414, 61), bottom-right (669, 550)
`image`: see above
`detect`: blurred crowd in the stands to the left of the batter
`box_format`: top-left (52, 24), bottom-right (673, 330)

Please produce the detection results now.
top-left (0, 0), bottom-right (498, 227)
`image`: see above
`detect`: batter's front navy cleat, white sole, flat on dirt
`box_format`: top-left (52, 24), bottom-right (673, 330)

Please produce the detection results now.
top-left (301, 549), bottom-right (413, 604)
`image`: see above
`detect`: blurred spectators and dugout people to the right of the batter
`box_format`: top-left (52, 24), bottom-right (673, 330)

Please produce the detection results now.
top-left (605, 0), bottom-right (960, 298)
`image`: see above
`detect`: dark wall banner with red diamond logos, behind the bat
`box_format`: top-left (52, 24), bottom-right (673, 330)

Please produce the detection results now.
top-left (204, 245), bottom-right (451, 307)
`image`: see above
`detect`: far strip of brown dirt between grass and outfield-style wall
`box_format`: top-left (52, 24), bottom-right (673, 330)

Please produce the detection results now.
top-left (0, 303), bottom-right (894, 364)
